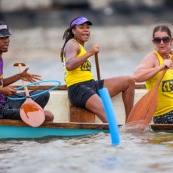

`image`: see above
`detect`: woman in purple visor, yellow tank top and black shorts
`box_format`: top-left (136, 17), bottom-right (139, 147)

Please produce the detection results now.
top-left (60, 17), bottom-right (135, 123)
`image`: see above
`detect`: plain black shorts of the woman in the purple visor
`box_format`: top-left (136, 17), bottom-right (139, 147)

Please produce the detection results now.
top-left (68, 80), bottom-right (104, 108)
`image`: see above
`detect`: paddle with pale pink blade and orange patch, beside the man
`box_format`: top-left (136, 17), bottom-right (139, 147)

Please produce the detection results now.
top-left (14, 63), bottom-right (45, 127)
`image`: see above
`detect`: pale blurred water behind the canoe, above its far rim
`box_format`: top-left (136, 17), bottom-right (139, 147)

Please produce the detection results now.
top-left (4, 53), bottom-right (144, 84)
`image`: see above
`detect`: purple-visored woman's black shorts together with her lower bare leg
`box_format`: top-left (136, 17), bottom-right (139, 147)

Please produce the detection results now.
top-left (68, 80), bottom-right (107, 123)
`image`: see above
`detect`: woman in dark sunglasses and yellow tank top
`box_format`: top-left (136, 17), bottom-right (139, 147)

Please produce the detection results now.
top-left (134, 25), bottom-right (173, 124)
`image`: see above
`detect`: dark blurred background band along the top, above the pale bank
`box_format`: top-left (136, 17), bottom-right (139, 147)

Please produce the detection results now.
top-left (0, 0), bottom-right (173, 29)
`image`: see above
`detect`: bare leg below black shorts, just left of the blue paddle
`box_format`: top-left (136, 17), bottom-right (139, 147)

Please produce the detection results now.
top-left (85, 94), bottom-right (108, 123)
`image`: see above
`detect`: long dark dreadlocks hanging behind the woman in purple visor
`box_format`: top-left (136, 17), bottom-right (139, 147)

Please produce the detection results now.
top-left (60, 28), bottom-right (74, 62)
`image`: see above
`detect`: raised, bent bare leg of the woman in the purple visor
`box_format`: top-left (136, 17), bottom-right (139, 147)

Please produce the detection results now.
top-left (104, 76), bottom-right (135, 120)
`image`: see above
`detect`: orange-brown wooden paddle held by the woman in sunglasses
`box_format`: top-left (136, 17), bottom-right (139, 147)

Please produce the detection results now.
top-left (126, 68), bottom-right (167, 131)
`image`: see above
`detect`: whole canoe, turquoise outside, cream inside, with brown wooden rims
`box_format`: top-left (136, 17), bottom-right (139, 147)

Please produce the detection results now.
top-left (0, 85), bottom-right (173, 139)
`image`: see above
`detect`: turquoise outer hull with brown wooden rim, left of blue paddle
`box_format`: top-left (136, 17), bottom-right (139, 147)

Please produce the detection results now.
top-left (0, 119), bottom-right (109, 139)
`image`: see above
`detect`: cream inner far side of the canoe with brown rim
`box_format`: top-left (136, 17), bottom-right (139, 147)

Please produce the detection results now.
top-left (10, 84), bottom-right (147, 124)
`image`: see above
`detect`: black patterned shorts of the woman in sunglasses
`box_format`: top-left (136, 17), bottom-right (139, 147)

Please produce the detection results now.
top-left (153, 111), bottom-right (173, 124)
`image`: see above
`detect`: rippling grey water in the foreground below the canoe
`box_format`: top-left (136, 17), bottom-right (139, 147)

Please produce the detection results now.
top-left (0, 128), bottom-right (173, 173)
